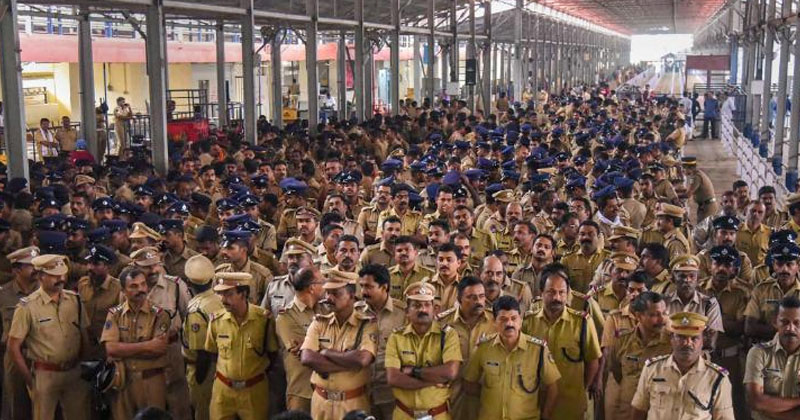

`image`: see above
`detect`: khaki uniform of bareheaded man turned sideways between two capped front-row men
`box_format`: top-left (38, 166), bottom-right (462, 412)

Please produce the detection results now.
top-left (276, 297), bottom-right (316, 399)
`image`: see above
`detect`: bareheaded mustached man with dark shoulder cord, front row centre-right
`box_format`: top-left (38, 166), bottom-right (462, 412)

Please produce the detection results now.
top-left (464, 296), bottom-right (561, 419)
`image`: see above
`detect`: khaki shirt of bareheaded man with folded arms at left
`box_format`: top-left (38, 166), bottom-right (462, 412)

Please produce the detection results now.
top-left (100, 300), bottom-right (171, 372)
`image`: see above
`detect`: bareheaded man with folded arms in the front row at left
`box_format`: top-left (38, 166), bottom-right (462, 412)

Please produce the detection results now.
top-left (100, 267), bottom-right (175, 420)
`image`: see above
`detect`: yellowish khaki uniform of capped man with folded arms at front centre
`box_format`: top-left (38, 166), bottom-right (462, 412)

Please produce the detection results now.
top-left (386, 321), bottom-right (463, 420)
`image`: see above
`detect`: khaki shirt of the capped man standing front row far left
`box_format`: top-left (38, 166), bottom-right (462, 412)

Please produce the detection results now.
top-left (8, 287), bottom-right (89, 364)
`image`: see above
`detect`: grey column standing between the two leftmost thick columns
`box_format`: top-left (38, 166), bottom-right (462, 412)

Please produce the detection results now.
top-left (77, 12), bottom-right (98, 162)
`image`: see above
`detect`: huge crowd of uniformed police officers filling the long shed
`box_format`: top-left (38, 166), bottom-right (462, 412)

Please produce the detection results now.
top-left (0, 79), bottom-right (800, 420)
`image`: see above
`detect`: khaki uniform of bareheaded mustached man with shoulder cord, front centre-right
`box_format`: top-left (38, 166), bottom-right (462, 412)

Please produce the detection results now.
top-left (464, 334), bottom-right (561, 420)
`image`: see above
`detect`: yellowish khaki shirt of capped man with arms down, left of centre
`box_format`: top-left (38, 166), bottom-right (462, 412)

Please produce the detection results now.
top-left (205, 303), bottom-right (278, 381)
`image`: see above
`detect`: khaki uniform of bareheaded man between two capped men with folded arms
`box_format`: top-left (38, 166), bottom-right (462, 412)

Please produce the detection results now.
top-left (355, 296), bottom-right (406, 419)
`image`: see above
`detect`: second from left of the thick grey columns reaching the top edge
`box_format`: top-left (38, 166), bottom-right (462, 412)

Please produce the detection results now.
top-left (146, 1), bottom-right (169, 175)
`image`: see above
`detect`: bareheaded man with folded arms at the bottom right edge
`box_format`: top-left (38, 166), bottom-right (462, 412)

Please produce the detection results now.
top-left (735, 296), bottom-right (800, 420)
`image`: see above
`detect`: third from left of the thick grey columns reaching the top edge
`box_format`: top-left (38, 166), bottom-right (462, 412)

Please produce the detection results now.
top-left (240, 0), bottom-right (258, 144)
